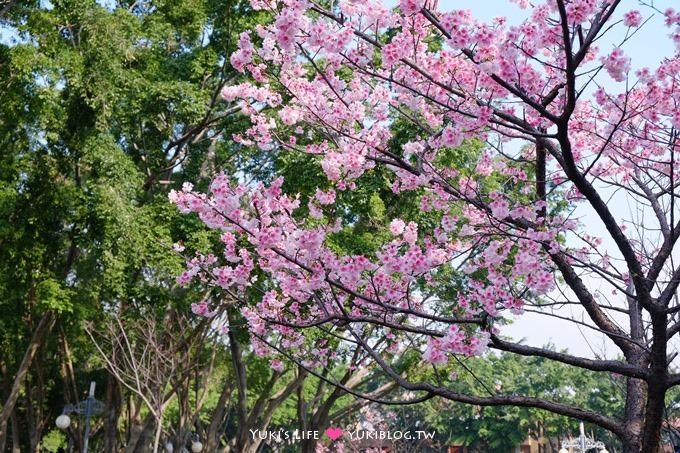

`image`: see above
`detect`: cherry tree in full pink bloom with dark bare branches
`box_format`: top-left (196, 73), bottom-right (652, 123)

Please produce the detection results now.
top-left (170, 0), bottom-right (680, 452)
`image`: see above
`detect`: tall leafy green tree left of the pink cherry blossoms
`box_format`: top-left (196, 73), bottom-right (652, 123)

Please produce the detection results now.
top-left (0, 1), bottom-right (257, 446)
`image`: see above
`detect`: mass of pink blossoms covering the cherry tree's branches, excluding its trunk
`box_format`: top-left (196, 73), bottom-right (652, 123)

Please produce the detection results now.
top-left (171, 0), bottom-right (680, 366)
